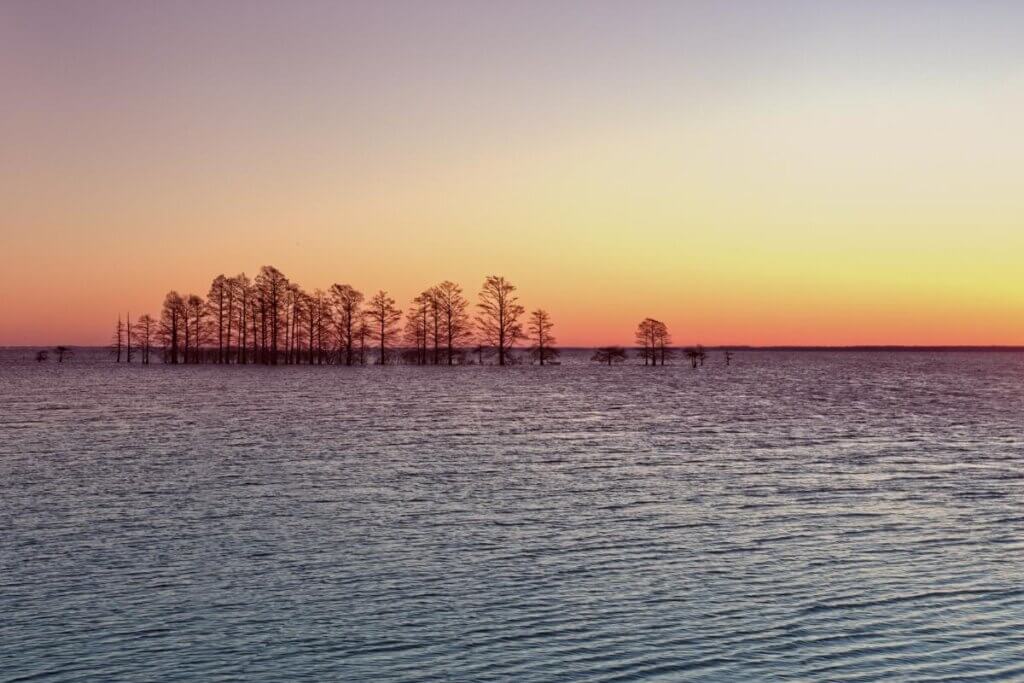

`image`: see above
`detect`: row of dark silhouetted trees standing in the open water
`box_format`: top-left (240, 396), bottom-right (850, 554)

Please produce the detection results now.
top-left (101, 265), bottom-right (705, 367)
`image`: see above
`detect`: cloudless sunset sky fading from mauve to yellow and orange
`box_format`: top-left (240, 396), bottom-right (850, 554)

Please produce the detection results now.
top-left (0, 0), bottom-right (1024, 345)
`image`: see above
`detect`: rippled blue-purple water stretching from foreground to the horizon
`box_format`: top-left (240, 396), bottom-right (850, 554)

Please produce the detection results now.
top-left (0, 352), bottom-right (1024, 681)
